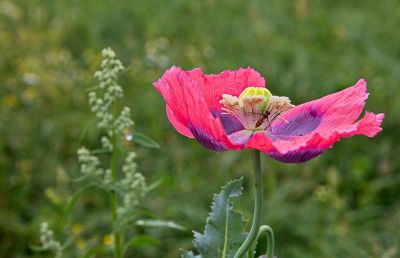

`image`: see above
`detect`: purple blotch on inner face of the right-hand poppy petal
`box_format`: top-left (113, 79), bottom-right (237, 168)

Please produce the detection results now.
top-left (271, 108), bottom-right (322, 138)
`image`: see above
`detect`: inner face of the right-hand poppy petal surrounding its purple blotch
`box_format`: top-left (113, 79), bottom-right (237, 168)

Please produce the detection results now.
top-left (271, 79), bottom-right (378, 154)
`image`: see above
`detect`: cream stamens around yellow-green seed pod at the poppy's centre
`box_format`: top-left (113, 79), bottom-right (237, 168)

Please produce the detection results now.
top-left (219, 87), bottom-right (294, 131)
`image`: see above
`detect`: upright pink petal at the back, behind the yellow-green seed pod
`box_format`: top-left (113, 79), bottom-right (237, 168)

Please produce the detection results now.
top-left (185, 67), bottom-right (265, 110)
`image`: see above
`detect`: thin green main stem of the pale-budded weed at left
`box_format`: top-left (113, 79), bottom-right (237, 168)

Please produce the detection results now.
top-left (110, 127), bottom-right (122, 258)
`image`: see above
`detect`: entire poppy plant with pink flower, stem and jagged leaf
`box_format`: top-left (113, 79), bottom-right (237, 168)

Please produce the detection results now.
top-left (154, 66), bottom-right (384, 258)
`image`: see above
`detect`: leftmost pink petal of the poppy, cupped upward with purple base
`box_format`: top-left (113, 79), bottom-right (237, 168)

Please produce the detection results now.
top-left (154, 67), bottom-right (242, 151)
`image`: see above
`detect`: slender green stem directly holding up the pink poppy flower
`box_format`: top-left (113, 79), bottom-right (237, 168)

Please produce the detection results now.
top-left (234, 150), bottom-right (263, 258)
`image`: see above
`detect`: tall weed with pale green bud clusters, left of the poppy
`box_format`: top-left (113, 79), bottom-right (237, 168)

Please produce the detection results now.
top-left (34, 48), bottom-right (183, 258)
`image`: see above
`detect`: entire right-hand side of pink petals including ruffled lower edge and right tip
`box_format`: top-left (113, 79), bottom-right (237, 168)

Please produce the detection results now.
top-left (246, 80), bottom-right (384, 163)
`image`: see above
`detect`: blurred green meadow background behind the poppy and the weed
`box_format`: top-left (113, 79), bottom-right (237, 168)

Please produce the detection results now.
top-left (0, 0), bottom-right (400, 258)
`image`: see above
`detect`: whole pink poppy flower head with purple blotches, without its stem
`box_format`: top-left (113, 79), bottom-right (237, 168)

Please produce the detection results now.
top-left (154, 66), bottom-right (384, 163)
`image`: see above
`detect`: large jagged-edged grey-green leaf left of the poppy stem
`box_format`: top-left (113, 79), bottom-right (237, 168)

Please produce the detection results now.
top-left (182, 178), bottom-right (246, 258)
